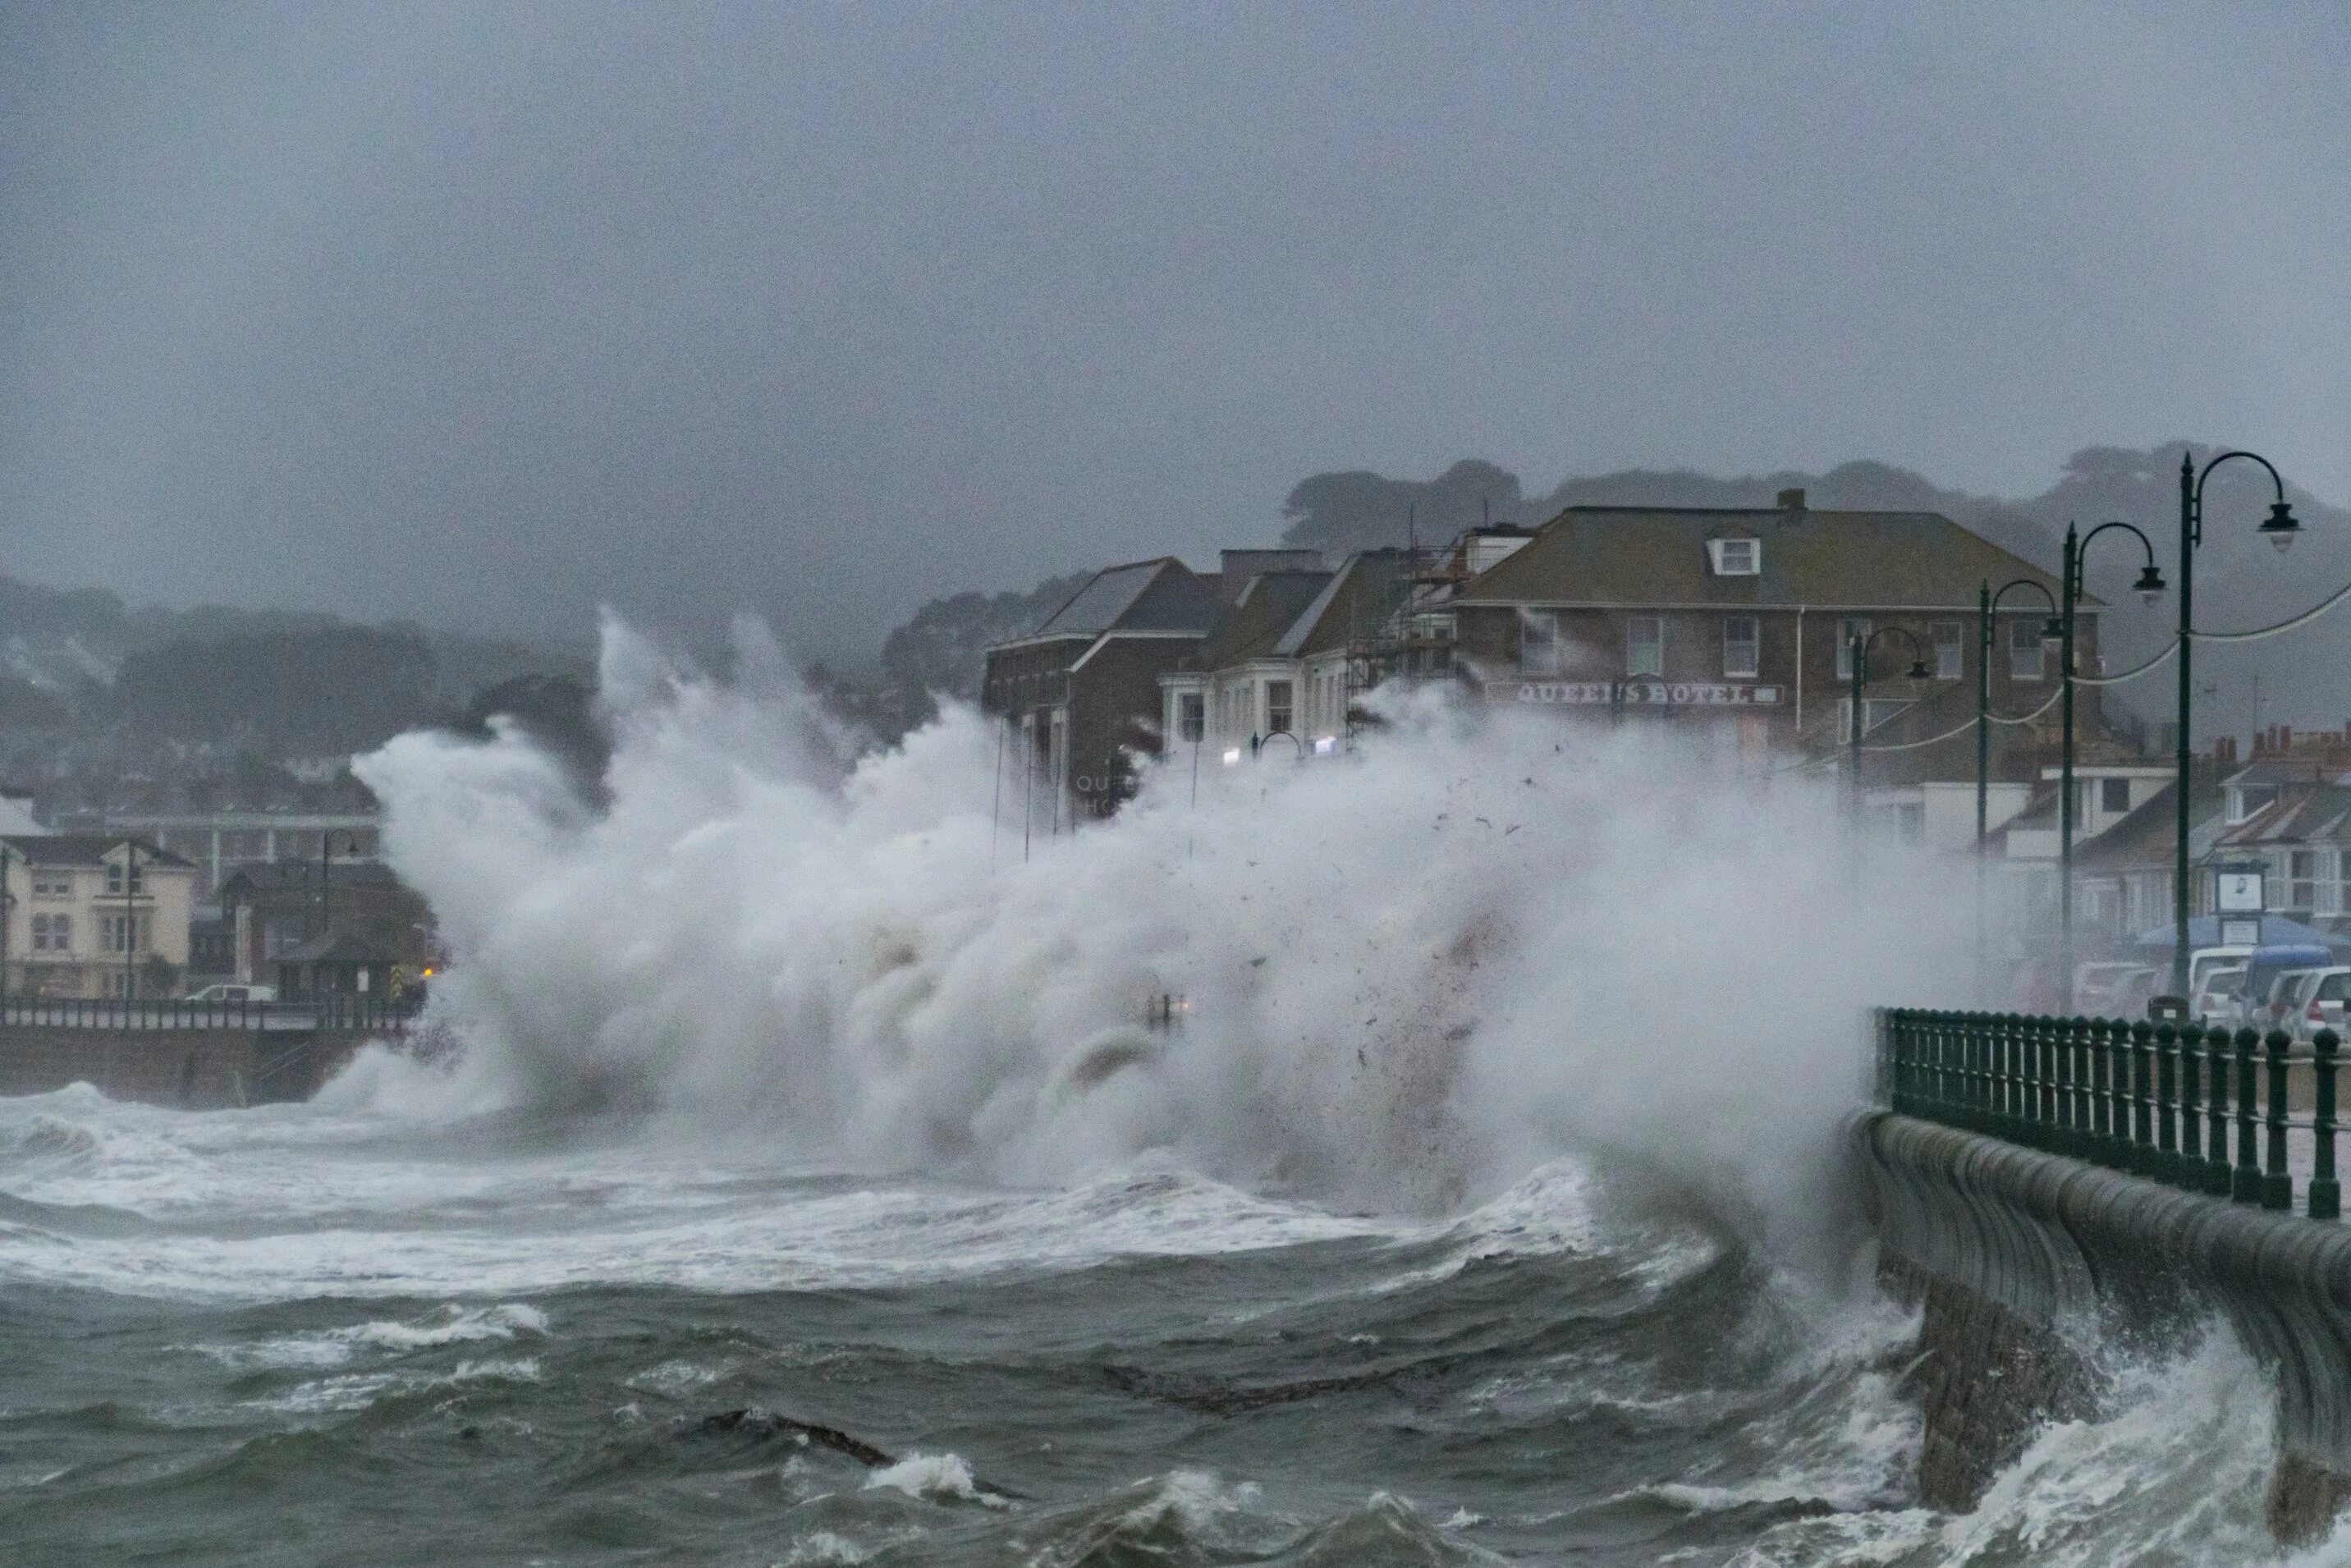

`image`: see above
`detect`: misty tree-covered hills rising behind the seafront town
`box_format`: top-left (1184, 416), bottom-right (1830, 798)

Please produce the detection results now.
top-left (0, 442), bottom-right (2351, 771)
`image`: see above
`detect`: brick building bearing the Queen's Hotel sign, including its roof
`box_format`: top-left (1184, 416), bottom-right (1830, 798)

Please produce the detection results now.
top-left (1443, 491), bottom-right (2100, 778)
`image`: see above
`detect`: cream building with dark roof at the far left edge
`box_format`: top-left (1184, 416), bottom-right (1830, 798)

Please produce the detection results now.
top-left (0, 832), bottom-right (195, 997)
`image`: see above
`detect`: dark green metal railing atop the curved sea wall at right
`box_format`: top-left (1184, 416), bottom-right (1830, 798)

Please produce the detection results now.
top-left (1878, 1008), bottom-right (2342, 1220)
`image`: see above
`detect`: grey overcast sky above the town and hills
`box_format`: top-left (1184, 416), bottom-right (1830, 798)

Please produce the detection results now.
top-left (0, 0), bottom-right (2351, 658)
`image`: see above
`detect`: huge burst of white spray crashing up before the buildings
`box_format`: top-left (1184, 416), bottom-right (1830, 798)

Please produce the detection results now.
top-left (362, 626), bottom-right (1970, 1240)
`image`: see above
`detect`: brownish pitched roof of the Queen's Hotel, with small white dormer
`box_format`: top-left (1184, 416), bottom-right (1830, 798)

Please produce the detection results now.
top-left (1458, 506), bottom-right (2090, 609)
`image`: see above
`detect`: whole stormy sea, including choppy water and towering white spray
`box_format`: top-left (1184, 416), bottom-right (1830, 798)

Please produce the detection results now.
top-left (0, 630), bottom-right (2346, 1566)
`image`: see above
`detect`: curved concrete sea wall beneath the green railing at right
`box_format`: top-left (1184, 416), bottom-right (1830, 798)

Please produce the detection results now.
top-left (1853, 1112), bottom-right (2351, 1540)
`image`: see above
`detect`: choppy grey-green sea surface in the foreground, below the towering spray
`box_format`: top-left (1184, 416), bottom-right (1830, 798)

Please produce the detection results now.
top-left (0, 1091), bottom-right (2340, 1563)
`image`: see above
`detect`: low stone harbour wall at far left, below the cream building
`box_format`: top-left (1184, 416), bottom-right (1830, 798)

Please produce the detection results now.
top-left (0, 1023), bottom-right (367, 1110)
